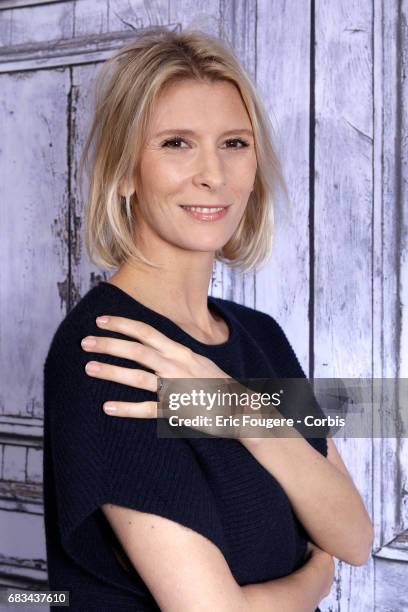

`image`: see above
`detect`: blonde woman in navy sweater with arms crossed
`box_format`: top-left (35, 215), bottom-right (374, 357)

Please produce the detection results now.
top-left (44, 28), bottom-right (372, 612)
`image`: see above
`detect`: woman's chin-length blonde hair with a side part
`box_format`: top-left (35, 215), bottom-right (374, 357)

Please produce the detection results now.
top-left (79, 26), bottom-right (289, 271)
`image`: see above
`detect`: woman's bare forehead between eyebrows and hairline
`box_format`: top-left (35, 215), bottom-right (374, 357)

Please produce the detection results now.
top-left (150, 79), bottom-right (251, 133)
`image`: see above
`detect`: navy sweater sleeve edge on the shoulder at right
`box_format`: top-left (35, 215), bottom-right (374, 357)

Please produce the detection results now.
top-left (263, 313), bottom-right (327, 457)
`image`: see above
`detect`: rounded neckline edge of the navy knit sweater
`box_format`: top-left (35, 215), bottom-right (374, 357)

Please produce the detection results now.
top-left (98, 281), bottom-right (237, 350)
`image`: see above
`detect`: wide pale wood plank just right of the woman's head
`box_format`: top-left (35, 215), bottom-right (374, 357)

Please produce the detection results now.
top-left (311, 0), bottom-right (374, 612)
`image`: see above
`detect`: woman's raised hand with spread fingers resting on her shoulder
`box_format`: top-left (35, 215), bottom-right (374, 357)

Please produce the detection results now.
top-left (81, 315), bottom-right (237, 433)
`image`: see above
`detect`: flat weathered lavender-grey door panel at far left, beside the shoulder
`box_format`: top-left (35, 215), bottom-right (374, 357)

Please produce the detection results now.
top-left (0, 70), bottom-right (69, 417)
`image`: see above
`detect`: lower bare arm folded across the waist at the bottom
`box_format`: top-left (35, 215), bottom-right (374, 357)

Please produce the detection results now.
top-left (102, 504), bottom-right (333, 612)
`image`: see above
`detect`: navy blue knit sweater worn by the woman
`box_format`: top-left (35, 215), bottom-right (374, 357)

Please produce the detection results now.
top-left (43, 281), bottom-right (327, 612)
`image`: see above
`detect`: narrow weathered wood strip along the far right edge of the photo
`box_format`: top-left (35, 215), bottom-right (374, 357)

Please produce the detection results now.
top-left (373, 3), bottom-right (408, 568)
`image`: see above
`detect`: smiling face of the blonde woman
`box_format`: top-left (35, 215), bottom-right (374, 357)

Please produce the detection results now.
top-left (129, 80), bottom-right (257, 261)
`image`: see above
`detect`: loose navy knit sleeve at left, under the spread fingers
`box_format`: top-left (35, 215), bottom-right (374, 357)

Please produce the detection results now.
top-left (44, 308), bottom-right (224, 592)
